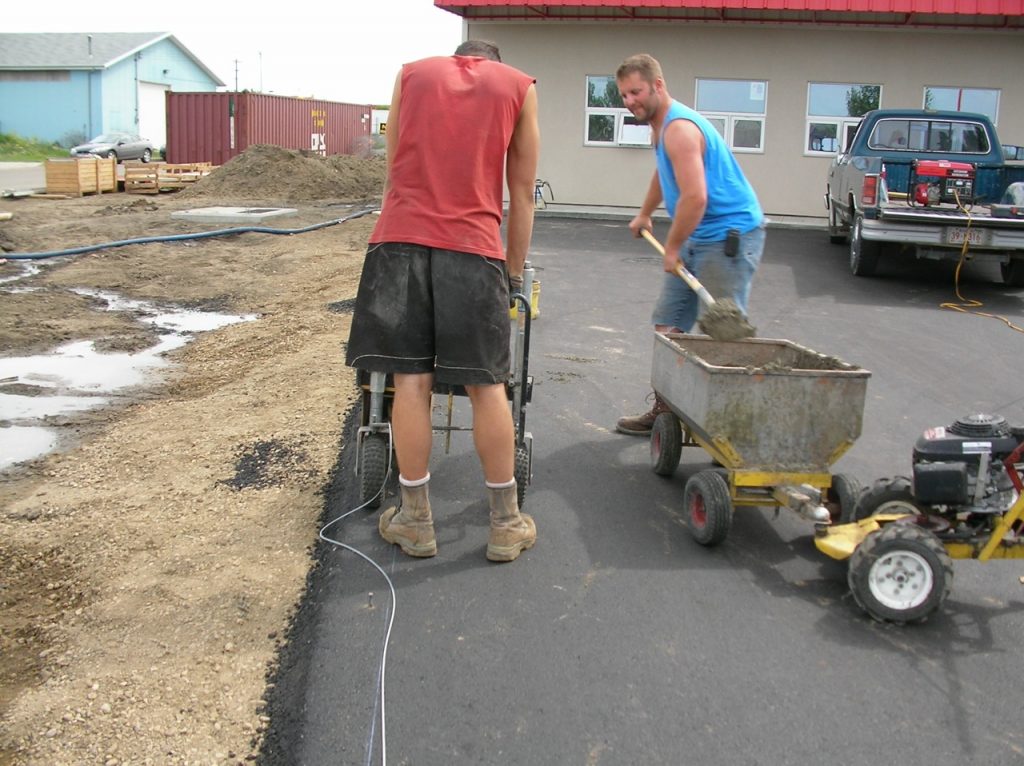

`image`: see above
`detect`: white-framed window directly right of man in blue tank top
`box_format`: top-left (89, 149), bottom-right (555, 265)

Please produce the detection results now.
top-left (695, 79), bottom-right (768, 154)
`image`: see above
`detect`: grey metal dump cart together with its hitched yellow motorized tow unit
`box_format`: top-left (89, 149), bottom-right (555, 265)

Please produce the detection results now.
top-left (650, 333), bottom-right (1024, 623)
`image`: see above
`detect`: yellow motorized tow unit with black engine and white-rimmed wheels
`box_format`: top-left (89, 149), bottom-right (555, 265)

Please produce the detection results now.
top-left (815, 414), bottom-right (1024, 623)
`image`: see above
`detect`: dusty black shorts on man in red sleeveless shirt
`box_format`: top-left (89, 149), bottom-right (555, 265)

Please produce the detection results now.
top-left (345, 242), bottom-right (511, 385)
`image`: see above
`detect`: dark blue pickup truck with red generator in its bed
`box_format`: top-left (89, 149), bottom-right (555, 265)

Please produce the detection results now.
top-left (825, 110), bottom-right (1024, 287)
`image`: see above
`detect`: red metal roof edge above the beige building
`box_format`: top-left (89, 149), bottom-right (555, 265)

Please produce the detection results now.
top-left (434, 0), bottom-right (1024, 30)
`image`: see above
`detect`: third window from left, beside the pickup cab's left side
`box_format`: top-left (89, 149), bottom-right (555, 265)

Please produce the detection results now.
top-left (804, 83), bottom-right (882, 157)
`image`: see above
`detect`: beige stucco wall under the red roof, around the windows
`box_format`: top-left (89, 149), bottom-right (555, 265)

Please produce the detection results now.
top-left (466, 19), bottom-right (1024, 217)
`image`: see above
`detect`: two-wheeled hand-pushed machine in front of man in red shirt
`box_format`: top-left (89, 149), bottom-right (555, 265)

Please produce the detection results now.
top-left (355, 261), bottom-right (535, 510)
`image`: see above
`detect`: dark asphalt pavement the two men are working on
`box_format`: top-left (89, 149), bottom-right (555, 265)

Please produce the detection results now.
top-left (249, 218), bottom-right (1024, 766)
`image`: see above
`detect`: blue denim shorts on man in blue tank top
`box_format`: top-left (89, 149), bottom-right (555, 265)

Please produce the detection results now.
top-left (650, 224), bottom-right (765, 333)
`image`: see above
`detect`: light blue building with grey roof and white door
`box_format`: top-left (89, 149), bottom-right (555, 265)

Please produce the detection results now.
top-left (0, 32), bottom-right (224, 147)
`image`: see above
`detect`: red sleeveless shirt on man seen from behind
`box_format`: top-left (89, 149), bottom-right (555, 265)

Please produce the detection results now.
top-left (370, 56), bottom-right (535, 260)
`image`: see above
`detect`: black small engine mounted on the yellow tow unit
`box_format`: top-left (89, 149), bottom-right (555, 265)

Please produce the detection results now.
top-left (913, 414), bottom-right (1024, 514)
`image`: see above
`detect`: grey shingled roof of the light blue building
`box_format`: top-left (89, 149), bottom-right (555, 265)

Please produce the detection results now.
top-left (0, 32), bottom-right (224, 85)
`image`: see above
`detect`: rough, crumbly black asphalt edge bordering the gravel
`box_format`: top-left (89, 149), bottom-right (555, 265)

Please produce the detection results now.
top-left (256, 399), bottom-right (360, 766)
